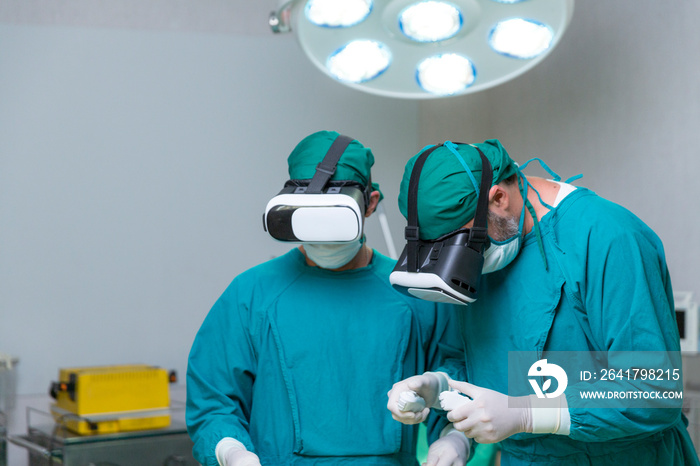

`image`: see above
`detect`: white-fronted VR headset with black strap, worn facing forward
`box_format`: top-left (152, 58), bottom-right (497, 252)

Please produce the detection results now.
top-left (263, 135), bottom-right (372, 243)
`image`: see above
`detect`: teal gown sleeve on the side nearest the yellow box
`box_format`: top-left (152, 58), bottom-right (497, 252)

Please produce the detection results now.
top-left (186, 277), bottom-right (256, 466)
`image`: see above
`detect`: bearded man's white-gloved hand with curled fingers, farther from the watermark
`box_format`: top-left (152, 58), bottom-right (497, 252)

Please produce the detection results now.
top-left (386, 372), bottom-right (449, 424)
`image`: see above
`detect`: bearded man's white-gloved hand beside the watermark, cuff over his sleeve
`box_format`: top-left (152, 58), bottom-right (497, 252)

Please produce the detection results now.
top-left (447, 380), bottom-right (532, 443)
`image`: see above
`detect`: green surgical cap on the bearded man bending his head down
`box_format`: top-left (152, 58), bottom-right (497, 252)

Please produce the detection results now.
top-left (399, 139), bottom-right (517, 240)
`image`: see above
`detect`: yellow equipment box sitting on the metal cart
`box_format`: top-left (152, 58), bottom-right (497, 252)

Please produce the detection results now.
top-left (50, 364), bottom-right (173, 435)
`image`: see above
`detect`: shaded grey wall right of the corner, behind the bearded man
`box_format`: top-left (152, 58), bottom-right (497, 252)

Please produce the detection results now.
top-left (420, 0), bottom-right (700, 300)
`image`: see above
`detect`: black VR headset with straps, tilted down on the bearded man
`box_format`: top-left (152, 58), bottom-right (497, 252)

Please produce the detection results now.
top-left (389, 144), bottom-right (493, 305)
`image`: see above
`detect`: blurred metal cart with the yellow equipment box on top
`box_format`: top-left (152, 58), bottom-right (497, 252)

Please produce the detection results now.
top-left (8, 364), bottom-right (198, 466)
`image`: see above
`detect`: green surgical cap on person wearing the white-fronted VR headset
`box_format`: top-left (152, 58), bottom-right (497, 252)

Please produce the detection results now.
top-left (287, 131), bottom-right (384, 200)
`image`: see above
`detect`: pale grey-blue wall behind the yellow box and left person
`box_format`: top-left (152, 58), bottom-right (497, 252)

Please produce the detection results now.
top-left (0, 24), bottom-right (418, 393)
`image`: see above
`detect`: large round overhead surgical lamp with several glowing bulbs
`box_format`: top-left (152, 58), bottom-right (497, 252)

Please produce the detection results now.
top-left (269, 0), bottom-right (574, 99)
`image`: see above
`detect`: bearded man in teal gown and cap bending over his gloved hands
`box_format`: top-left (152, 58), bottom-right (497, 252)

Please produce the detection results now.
top-left (388, 140), bottom-right (699, 466)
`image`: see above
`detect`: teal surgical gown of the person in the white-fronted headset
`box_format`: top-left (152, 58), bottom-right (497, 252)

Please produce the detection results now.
top-left (187, 249), bottom-right (462, 466)
